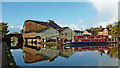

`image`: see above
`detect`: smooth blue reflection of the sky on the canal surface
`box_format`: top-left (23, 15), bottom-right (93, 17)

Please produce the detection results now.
top-left (11, 49), bottom-right (118, 66)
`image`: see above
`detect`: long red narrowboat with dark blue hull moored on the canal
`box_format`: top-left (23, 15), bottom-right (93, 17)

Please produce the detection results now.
top-left (66, 36), bottom-right (108, 44)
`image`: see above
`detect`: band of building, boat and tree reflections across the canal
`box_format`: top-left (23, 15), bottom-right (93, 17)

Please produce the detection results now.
top-left (23, 43), bottom-right (118, 63)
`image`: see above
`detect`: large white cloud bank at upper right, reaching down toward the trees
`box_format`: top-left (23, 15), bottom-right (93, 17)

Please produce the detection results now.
top-left (89, 0), bottom-right (119, 26)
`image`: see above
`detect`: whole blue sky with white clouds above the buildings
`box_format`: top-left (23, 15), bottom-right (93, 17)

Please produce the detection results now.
top-left (0, 0), bottom-right (118, 32)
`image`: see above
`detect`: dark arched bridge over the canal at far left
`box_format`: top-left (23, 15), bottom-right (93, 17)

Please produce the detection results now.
top-left (4, 34), bottom-right (23, 49)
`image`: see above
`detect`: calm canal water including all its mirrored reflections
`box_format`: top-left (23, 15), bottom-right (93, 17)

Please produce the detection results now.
top-left (10, 43), bottom-right (120, 66)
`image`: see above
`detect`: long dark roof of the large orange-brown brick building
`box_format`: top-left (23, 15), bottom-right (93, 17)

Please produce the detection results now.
top-left (25, 20), bottom-right (61, 29)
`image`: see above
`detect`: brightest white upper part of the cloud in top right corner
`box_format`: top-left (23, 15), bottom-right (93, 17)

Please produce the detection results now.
top-left (89, 0), bottom-right (119, 15)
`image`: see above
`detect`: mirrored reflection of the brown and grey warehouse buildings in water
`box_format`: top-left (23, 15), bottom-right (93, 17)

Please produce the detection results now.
top-left (23, 43), bottom-right (74, 63)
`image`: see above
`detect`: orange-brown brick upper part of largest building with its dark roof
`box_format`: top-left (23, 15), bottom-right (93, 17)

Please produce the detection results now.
top-left (23, 20), bottom-right (61, 33)
